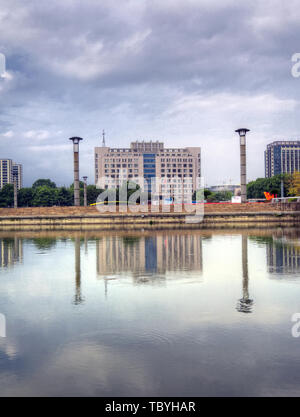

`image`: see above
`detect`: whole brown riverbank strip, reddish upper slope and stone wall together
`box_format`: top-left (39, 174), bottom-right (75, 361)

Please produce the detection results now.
top-left (0, 203), bottom-right (300, 230)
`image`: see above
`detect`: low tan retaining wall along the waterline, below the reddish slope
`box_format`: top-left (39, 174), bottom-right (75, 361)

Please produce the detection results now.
top-left (0, 211), bottom-right (300, 230)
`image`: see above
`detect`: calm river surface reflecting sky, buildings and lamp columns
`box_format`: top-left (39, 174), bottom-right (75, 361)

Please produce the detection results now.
top-left (0, 229), bottom-right (300, 396)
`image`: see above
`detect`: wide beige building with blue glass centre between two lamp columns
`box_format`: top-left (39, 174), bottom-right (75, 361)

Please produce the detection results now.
top-left (95, 141), bottom-right (201, 191)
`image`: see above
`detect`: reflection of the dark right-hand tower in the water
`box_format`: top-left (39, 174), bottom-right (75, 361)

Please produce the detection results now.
top-left (267, 236), bottom-right (300, 277)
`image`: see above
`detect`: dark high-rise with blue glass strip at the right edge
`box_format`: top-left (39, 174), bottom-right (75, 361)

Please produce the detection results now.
top-left (265, 141), bottom-right (300, 178)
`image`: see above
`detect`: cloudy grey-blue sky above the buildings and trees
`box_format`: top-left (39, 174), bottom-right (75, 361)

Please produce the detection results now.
top-left (0, 0), bottom-right (300, 185)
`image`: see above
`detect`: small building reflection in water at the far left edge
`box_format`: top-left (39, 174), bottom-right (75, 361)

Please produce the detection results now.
top-left (0, 237), bottom-right (23, 268)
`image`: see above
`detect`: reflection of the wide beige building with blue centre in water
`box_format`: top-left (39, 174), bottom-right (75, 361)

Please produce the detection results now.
top-left (96, 234), bottom-right (202, 283)
